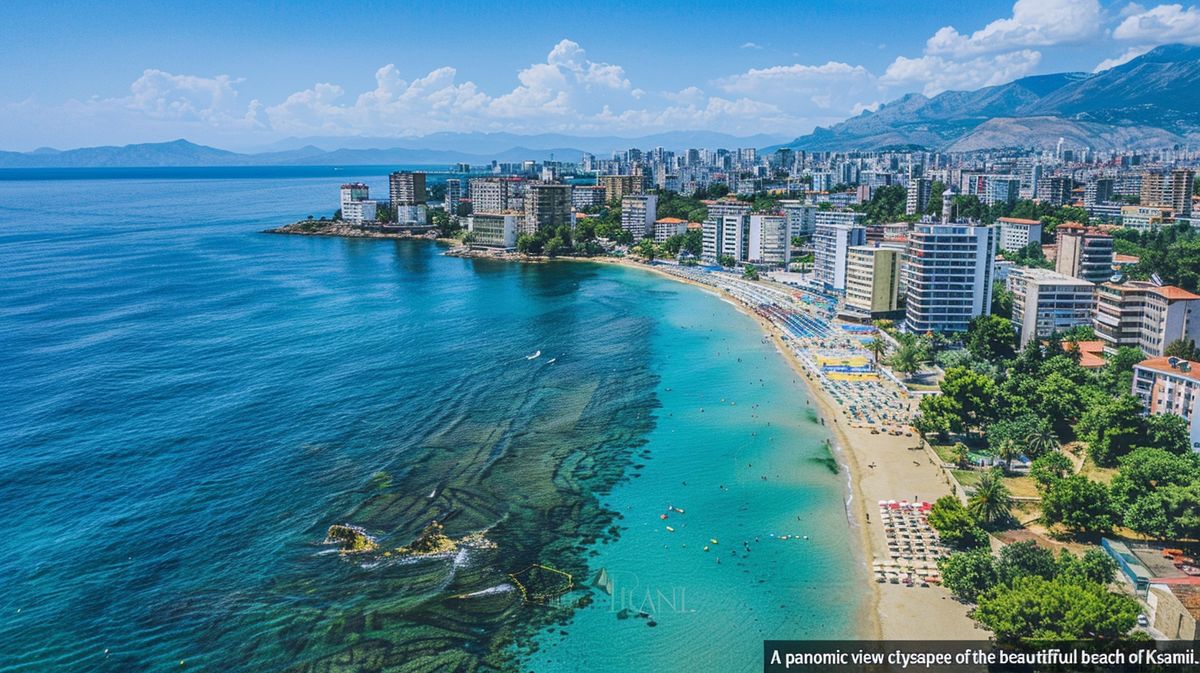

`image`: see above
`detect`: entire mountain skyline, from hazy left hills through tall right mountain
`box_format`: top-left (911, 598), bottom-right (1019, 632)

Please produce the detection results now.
top-left (9, 44), bottom-right (1200, 168)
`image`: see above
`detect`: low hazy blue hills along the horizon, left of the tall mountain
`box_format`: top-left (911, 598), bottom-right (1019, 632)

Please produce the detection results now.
top-left (0, 131), bottom-right (786, 168)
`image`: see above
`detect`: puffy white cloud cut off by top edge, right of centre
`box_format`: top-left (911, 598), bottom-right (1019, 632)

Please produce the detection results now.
top-left (925, 0), bottom-right (1102, 56)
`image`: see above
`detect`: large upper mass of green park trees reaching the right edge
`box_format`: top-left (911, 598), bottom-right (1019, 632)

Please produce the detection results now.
top-left (907, 316), bottom-right (1200, 545)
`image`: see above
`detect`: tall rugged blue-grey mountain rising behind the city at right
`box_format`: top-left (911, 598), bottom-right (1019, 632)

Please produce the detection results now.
top-left (782, 44), bottom-right (1200, 151)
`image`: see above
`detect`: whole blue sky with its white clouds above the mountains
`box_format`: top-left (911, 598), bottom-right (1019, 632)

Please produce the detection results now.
top-left (0, 0), bottom-right (1200, 150)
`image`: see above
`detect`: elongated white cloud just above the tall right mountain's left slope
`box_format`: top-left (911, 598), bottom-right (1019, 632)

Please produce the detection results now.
top-left (881, 49), bottom-right (1042, 96)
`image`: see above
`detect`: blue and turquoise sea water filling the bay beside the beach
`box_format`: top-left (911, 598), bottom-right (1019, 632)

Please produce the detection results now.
top-left (0, 170), bottom-right (869, 672)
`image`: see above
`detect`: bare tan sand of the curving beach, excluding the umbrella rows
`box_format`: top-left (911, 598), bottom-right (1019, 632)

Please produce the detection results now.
top-left (586, 258), bottom-right (988, 639)
